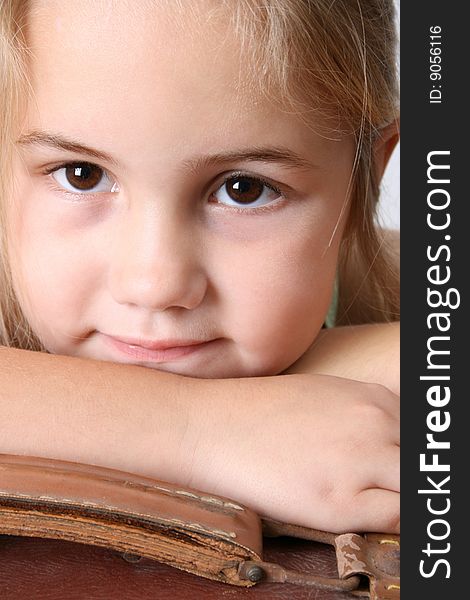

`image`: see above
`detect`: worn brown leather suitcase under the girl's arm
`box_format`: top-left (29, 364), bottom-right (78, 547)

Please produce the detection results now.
top-left (0, 455), bottom-right (399, 600)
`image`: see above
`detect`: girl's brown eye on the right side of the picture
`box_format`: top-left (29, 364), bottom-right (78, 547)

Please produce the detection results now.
top-left (214, 175), bottom-right (281, 208)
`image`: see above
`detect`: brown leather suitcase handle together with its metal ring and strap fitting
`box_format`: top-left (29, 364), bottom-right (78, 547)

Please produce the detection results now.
top-left (0, 454), bottom-right (399, 600)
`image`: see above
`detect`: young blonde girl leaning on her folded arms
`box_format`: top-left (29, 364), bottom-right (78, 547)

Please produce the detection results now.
top-left (0, 0), bottom-right (399, 532)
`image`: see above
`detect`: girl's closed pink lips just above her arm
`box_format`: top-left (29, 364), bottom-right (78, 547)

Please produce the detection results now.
top-left (101, 333), bottom-right (221, 363)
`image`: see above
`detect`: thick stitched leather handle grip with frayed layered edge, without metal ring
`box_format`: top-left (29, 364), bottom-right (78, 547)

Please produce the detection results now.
top-left (0, 455), bottom-right (262, 586)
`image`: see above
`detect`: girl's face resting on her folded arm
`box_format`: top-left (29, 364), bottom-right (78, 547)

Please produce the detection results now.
top-left (9, 0), bottom-right (354, 377)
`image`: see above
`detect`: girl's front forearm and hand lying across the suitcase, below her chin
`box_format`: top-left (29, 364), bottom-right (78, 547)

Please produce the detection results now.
top-left (0, 348), bottom-right (399, 532)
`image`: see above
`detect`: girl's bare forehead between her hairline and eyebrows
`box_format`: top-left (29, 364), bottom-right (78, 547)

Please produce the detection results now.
top-left (23, 0), bottom-right (352, 170)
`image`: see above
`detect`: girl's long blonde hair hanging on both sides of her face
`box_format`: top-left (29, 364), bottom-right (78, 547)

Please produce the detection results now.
top-left (0, 0), bottom-right (399, 350)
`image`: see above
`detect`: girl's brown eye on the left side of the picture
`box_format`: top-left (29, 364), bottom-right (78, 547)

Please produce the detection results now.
top-left (52, 163), bottom-right (118, 194)
